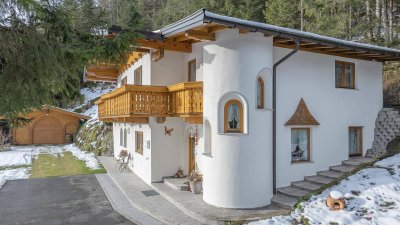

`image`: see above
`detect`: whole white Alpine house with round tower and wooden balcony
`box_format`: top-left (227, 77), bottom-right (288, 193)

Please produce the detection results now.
top-left (90, 10), bottom-right (400, 208)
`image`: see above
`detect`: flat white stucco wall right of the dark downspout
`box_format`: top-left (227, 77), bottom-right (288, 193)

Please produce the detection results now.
top-left (274, 47), bottom-right (383, 187)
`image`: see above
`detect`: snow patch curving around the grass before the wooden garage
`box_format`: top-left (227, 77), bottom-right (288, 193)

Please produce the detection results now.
top-left (0, 144), bottom-right (100, 188)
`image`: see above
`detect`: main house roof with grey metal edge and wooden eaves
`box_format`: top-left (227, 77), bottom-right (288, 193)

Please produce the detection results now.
top-left (141, 9), bottom-right (400, 61)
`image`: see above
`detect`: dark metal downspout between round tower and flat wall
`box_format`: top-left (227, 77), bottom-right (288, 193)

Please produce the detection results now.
top-left (272, 39), bottom-right (300, 194)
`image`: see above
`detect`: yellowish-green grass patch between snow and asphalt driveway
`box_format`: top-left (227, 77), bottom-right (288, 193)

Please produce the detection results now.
top-left (30, 152), bottom-right (106, 178)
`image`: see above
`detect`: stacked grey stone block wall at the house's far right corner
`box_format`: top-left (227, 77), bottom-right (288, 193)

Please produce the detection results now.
top-left (366, 108), bottom-right (400, 156)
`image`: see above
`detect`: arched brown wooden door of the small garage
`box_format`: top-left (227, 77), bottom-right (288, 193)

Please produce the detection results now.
top-left (33, 117), bottom-right (64, 144)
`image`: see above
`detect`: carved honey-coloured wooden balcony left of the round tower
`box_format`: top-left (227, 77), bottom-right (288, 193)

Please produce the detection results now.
top-left (96, 82), bottom-right (203, 124)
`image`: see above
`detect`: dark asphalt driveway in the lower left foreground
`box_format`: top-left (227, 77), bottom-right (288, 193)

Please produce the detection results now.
top-left (0, 175), bottom-right (133, 225)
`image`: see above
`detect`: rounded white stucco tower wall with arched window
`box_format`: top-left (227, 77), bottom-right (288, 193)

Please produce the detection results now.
top-left (203, 30), bottom-right (273, 208)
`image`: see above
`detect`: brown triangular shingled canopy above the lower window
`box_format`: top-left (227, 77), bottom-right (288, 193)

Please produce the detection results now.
top-left (285, 98), bottom-right (319, 126)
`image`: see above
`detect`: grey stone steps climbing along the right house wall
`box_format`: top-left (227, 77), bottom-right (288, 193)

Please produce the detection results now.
top-left (271, 157), bottom-right (373, 210)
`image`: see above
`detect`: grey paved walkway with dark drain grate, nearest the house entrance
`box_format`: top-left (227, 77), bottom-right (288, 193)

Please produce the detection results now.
top-left (98, 156), bottom-right (204, 225)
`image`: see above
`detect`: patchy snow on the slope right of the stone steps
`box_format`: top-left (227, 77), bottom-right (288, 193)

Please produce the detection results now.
top-left (250, 154), bottom-right (400, 225)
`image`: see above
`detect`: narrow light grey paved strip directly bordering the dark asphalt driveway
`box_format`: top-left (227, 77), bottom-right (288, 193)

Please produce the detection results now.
top-left (96, 173), bottom-right (164, 225)
